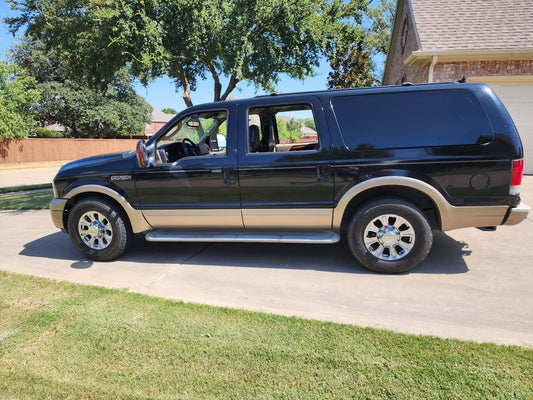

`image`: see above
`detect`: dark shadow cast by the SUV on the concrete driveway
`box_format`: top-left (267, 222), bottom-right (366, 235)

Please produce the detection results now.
top-left (19, 232), bottom-right (471, 274)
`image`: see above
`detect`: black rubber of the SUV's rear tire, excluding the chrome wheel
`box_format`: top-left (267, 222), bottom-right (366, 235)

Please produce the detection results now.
top-left (348, 199), bottom-right (433, 273)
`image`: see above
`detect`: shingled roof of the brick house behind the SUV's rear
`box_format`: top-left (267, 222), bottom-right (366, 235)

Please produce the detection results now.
top-left (410, 0), bottom-right (533, 52)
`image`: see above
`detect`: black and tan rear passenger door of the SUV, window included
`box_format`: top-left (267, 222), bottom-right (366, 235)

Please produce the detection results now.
top-left (238, 97), bottom-right (333, 231)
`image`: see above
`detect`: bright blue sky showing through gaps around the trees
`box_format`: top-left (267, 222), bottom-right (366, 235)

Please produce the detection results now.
top-left (0, 1), bottom-right (382, 111)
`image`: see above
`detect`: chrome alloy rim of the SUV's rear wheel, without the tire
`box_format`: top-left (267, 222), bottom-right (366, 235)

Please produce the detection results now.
top-left (364, 214), bottom-right (415, 261)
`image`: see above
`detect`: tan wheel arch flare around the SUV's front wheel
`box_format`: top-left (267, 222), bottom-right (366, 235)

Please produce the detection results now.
top-left (63, 185), bottom-right (151, 233)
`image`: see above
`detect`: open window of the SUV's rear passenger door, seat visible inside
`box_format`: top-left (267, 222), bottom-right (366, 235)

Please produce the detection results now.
top-left (247, 104), bottom-right (320, 154)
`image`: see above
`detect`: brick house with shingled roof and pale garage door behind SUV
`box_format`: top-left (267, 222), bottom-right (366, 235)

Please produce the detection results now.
top-left (383, 0), bottom-right (533, 174)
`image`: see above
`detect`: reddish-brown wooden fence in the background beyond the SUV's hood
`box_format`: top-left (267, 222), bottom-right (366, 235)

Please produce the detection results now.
top-left (0, 138), bottom-right (137, 164)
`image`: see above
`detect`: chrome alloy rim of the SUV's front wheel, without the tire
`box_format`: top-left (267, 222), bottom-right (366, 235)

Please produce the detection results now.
top-left (78, 211), bottom-right (113, 250)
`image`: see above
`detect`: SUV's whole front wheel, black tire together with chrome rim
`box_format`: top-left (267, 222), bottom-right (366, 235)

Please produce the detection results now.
top-left (68, 198), bottom-right (133, 261)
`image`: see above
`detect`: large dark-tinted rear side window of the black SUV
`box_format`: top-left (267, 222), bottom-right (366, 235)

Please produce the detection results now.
top-left (332, 90), bottom-right (493, 150)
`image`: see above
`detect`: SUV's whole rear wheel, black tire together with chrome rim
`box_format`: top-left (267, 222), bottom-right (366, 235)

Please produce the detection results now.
top-left (347, 198), bottom-right (433, 274)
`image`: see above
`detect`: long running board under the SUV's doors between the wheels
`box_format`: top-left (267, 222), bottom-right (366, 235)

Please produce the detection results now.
top-left (145, 230), bottom-right (340, 244)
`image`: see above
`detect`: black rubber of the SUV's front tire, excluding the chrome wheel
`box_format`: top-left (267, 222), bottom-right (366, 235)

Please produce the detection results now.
top-left (68, 199), bottom-right (131, 261)
